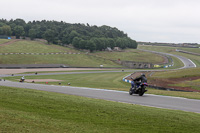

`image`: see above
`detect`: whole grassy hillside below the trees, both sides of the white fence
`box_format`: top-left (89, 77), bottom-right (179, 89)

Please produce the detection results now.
top-left (0, 40), bottom-right (169, 67)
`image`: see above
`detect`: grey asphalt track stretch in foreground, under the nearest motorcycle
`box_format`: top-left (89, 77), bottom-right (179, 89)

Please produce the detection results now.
top-left (0, 81), bottom-right (200, 113)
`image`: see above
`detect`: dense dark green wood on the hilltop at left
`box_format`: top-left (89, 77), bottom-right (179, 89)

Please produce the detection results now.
top-left (0, 19), bottom-right (137, 52)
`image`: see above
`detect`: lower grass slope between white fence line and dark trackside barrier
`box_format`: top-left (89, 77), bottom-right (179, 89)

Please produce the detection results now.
top-left (0, 54), bottom-right (122, 67)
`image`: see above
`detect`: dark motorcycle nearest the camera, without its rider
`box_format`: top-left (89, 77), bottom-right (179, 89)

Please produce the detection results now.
top-left (129, 83), bottom-right (148, 96)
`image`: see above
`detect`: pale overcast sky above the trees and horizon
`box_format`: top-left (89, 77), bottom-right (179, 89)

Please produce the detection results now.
top-left (0, 0), bottom-right (200, 43)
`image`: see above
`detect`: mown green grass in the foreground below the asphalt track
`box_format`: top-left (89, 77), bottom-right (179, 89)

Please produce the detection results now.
top-left (0, 86), bottom-right (200, 133)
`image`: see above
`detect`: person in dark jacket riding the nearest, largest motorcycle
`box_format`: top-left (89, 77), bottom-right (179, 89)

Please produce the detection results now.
top-left (131, 73), bottom-right (147, 89)
